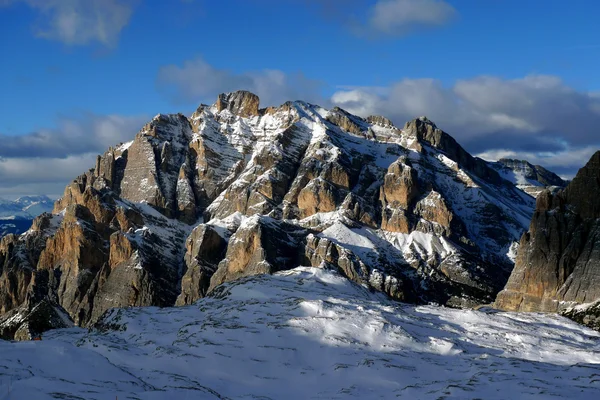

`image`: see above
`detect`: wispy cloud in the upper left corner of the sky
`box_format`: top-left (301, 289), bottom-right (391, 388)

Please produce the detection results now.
top-left (0, 0), bottom-right (136, 47)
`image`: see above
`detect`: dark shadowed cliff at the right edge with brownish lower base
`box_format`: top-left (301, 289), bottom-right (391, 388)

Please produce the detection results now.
top-left (496, 152), bottom-right (600, 324)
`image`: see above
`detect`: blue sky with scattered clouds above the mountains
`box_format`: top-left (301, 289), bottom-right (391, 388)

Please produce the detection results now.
top-left (0, 0), bottom-right (600, 197)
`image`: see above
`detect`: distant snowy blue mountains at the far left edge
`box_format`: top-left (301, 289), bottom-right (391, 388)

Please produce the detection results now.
top-left (0, 196), bottom-right (54, 237)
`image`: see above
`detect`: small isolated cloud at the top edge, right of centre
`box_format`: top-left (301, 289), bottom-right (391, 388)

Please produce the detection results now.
top-left (367, 0), bottom-right (457, 36)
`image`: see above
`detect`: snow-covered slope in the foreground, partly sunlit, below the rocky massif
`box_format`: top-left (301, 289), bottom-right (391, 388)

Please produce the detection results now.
top-left (0, 268), bottom-right (600, 400)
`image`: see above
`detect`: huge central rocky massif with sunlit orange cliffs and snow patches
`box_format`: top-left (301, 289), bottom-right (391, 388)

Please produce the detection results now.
top-left (0, 91), bottom-right (533, 340)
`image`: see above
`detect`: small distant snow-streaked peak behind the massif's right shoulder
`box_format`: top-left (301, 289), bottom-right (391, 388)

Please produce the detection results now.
top-left (489, 158), bottom-right (568, 197)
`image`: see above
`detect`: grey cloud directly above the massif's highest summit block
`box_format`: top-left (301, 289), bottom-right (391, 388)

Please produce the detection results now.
top-left (156, 58), bottom-right (323, 106)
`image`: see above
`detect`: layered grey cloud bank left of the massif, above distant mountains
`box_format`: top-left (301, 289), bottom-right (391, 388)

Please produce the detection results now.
top-left (0, 113), bottom-right (149, 198)
